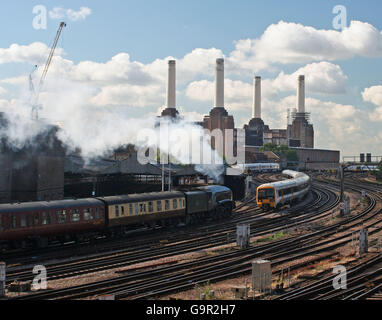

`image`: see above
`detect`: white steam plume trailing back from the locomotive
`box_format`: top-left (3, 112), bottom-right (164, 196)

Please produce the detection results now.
top-left (0, 79), bottom-right (224, 180)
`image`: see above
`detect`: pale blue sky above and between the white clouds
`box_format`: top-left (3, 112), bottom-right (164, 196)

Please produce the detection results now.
top-left (0, 0), bottom-right (382, 158)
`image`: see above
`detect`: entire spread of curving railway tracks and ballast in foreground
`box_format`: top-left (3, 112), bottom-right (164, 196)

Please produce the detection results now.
top-left (2, 173), bottom-right (382, 300)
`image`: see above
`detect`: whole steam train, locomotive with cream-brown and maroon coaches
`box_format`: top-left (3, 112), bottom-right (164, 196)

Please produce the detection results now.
top-left (0, 186), bottom-right (234, 249)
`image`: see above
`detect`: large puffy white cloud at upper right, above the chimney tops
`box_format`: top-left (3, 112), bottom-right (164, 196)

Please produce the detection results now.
top-left (229, 21), bottom-right (382, 72)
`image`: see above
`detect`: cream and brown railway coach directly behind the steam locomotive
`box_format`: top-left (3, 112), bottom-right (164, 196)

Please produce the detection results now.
top-left (99, 191), bottom-right (186, 228)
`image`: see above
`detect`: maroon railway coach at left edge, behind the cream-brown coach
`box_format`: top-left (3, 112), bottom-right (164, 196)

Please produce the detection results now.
top-left (0, 199), bottom-right (106, 244)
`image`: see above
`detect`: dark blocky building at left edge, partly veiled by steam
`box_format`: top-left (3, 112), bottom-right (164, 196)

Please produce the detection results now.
top-left (0, 114), bottom-right (65, 203)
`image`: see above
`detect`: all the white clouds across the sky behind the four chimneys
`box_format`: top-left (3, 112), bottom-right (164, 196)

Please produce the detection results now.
top-left (0, 18), bottom-right (382, 156)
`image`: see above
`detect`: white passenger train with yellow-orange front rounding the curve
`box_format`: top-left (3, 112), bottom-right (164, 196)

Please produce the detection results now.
top-left (256, 170), bottom-right (311, 210)
